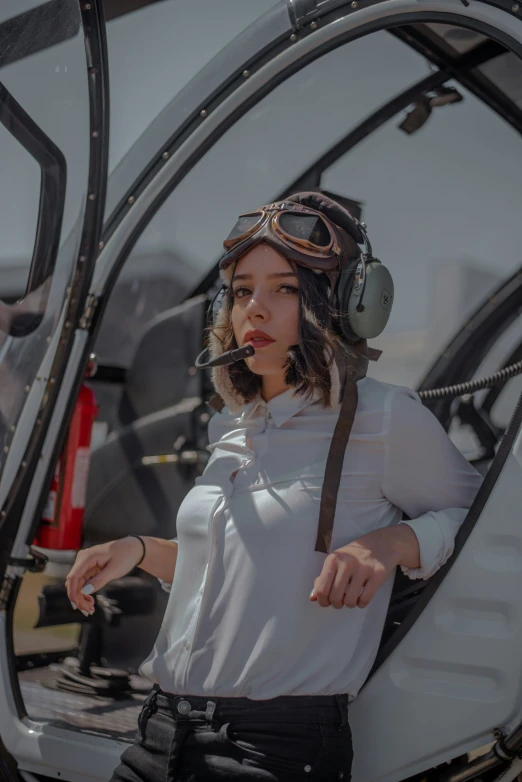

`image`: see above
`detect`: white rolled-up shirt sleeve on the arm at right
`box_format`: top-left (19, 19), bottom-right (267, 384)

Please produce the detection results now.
top-left (382, 388), bottom-right (482, 579)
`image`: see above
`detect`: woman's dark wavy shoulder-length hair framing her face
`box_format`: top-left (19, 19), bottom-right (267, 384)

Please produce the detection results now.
top-left (206, 261), bottom-right (342, 414)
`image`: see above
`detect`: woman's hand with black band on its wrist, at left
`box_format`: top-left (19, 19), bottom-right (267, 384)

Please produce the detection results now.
top-left (65, 538), bottom-right (143, 614)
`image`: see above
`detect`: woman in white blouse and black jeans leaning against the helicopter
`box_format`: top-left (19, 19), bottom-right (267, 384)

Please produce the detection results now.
top-left (67, 196), bottom-right (481, 782)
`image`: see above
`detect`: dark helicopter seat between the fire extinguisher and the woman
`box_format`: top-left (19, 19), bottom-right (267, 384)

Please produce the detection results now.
top-left (84, 296), bottom-right (208, 545)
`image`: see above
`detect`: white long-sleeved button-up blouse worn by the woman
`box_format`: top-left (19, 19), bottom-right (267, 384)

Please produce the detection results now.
top-left (140, 378), bottom-right (482, 699)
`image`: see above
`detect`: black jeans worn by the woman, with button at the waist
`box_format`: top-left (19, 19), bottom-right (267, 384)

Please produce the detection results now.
top-left (111, 686), bottom-right (353, 782)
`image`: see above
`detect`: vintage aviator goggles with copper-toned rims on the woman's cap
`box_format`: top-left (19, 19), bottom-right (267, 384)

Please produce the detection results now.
top-left (219, 200), bottom-right (360, 282)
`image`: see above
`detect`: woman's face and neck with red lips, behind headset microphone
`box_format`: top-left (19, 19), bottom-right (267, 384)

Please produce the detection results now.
top-left (231, 243), bottom-right (299, 401)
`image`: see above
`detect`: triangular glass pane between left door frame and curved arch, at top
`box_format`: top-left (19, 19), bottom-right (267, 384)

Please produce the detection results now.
top-left (107, 0), bottom-right (277, 171)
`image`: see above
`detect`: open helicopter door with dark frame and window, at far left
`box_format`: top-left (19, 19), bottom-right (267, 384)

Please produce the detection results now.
top-left (0, 0), bottom-right (108, 774)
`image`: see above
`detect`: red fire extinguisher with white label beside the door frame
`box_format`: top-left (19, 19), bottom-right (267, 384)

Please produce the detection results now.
top-left (34, 362), bottom-right (98, 551)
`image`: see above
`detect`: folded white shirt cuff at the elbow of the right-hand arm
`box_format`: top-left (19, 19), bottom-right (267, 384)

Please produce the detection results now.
top-left (399, 508), bottom-right (462, 580)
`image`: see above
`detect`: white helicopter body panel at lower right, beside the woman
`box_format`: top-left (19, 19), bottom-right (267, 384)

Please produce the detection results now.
top-left (350, 455), bottom-right (522, 782)
